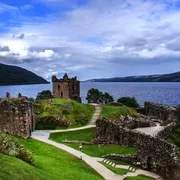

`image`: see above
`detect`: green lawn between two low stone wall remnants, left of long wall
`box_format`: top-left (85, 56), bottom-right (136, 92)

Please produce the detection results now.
top-left (66, 144), bottom-right (136, 157)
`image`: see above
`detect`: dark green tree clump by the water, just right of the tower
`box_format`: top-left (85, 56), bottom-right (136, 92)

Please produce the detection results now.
top-left (86, 88), bottom-right (114, 104)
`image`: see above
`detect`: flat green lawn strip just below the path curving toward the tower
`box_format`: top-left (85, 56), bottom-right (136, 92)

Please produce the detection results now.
top-left (49, 128), bottom-right (96, 143)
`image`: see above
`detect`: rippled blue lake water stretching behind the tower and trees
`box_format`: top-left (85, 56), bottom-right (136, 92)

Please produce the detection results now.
top-left (0, 82), bottom-right (180, 106)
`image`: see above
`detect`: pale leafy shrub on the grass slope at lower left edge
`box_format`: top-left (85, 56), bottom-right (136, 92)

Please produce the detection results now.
top-left (0, 133), bottom-right (34, 165)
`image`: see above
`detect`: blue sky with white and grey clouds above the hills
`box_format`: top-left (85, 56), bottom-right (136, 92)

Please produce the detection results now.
top-left (0, 0), bottom-right (180, 80)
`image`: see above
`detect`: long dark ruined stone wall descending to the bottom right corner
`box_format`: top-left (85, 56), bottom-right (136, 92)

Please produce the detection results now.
top-left (96, 118), bottom-right (180, 180)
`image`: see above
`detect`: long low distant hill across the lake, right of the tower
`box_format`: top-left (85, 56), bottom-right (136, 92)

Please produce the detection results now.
top-left (86, 71), bottom-right (180, 82)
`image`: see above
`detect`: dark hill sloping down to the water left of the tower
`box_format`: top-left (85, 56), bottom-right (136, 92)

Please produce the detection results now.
top-left (0, 63), bottom-right (49, 85)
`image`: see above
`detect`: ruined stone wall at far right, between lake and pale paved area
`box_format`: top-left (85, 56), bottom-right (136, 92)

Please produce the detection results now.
top-left (144, 102), bottom-right (177, 123)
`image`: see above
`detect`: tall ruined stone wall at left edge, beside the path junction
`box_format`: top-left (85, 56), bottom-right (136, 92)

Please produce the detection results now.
top-left (0, 99), bottom-right (35, 138)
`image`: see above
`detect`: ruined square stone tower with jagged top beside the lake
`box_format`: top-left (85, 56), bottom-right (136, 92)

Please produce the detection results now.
top-left (52, 73), bottom-right (80, 101)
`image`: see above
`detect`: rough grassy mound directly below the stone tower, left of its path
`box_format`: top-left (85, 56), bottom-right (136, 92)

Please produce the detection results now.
top-left (35, 99), bottom-right (94, 129)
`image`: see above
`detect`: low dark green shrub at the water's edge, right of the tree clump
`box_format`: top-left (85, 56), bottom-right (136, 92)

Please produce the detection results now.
top-left (117, 97), bottom-right (139, 108)
